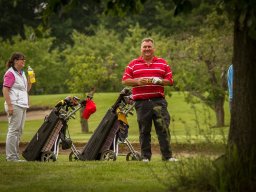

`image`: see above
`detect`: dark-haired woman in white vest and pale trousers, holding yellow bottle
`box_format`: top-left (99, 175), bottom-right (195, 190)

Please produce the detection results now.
top-left (3, 53), bottom-right (32, 161)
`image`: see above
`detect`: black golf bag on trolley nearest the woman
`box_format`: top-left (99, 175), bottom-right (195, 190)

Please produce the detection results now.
top-left (22, 96), bottom-right (91, 161)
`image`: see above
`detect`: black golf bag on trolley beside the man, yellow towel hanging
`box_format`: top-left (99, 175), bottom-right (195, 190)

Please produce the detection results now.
top-left (69, 88), bottom-right (141, 161)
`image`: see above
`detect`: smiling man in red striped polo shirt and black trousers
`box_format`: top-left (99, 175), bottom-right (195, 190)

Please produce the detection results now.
top-left (122, 38), bottom-right (177, 162)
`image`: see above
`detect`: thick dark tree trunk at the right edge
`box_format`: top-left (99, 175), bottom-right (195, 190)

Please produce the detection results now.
top-left (227, 11), bottom-right (256, 191)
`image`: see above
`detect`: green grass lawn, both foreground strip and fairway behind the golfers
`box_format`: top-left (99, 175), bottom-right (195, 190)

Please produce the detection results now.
top-left (0, 92), bottom-right (229, 192)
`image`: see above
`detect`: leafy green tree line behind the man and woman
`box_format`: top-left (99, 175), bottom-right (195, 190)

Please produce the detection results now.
top-left (0, 0), bottom-right (232, 126)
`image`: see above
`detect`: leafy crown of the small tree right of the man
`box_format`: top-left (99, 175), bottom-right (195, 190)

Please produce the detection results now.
top-left (167, 10), bottom-right (232, 108)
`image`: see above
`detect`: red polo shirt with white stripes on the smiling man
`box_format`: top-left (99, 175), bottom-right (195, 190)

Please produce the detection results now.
top-left (122, 56), bottom-right (173, 100)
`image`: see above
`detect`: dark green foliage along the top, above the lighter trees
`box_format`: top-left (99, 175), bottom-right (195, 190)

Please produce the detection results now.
top-left (0, 0), bottom-right (227, 49)
